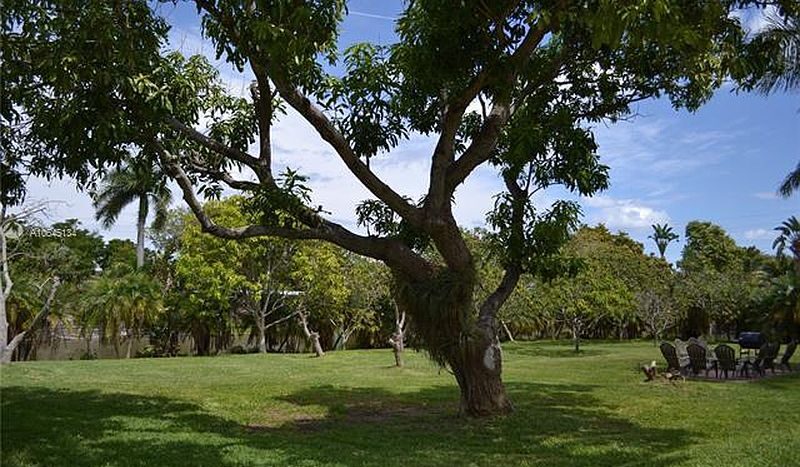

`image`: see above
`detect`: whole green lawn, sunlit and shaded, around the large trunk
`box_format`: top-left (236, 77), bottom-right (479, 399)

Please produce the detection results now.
top-left (1, 343), bottom-right (800, 467)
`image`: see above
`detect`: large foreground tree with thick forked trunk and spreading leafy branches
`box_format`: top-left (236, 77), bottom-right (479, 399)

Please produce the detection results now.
top-left (3, 0), bottom-right (798, 415)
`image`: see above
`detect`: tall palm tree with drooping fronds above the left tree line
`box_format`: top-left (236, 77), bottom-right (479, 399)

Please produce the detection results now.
top-left (93, 159), bottom-right (172, 268)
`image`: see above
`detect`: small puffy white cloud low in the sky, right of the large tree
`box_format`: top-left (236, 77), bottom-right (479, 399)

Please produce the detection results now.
top-left (581, 196), bottom-right (670, 230)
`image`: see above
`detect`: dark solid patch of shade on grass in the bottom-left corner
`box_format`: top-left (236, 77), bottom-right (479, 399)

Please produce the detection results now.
top-left (2, 387), bottom-right (244, 466)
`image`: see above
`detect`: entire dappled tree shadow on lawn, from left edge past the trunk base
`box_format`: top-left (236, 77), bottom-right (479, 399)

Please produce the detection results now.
top-left (2, 383), bottom-right (693, 466)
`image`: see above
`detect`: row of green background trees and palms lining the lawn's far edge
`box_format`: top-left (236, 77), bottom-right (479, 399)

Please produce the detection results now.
top-left (7, 195), bottom-right (800, 364)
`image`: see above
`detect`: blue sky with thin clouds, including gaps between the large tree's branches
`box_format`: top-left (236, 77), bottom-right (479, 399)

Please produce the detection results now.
top-left (31, 1), bottom-right (800, 261)
